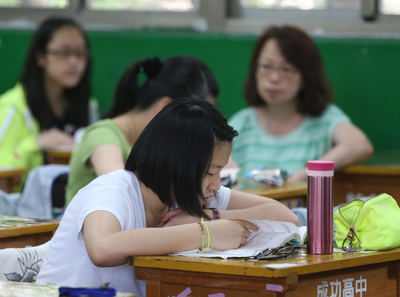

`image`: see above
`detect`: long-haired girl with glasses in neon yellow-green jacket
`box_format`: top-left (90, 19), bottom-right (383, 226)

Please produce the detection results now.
top-left (0, 17), bottom-right (97, 188)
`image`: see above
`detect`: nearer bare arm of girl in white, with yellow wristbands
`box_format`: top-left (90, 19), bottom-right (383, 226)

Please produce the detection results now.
top-left (82, 211), bottom-right (258, 267)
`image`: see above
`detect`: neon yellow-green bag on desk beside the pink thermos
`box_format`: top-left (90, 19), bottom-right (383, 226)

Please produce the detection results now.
top-left (333, 194), bottom-right (400, 252)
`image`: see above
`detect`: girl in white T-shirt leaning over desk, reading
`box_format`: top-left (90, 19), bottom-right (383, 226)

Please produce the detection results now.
top-left (37, 98), bottom-right (299, 297)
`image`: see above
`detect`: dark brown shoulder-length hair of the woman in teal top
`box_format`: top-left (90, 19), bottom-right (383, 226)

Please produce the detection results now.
top-left (245, 25), bottom-right (333, 116)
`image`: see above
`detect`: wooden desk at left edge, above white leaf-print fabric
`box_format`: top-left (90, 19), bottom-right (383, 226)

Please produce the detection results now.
top-left (0, 216), bottom-right (59, 249)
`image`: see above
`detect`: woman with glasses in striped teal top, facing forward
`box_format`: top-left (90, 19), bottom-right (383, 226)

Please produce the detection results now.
top-left (229, 26), bottom-right (373, 181)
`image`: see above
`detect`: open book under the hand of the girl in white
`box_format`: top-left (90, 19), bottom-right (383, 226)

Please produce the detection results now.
top-left (170, 220), bottom-right (307, 259)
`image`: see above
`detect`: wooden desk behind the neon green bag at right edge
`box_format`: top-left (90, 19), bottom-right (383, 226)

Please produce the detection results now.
top-left (333, 164), bottom-right (400, 205)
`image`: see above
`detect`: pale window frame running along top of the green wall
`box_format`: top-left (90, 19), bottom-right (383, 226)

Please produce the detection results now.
top-left (0, 0), bottom-right (400, 37)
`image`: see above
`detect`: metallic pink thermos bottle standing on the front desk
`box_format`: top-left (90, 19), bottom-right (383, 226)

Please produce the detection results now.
top-left (307, 161), bottom-right (334, 254)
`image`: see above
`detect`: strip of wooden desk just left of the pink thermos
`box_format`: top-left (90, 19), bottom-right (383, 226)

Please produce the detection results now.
top-left (241, 182), bottom-right (307, 208)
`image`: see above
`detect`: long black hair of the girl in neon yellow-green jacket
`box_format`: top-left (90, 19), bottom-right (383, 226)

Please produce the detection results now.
top-left (20, 16), bottom-right (91, 130)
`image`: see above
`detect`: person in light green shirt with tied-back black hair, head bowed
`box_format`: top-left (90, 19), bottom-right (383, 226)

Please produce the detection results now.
top-left (66, 56), bottom-right (219, 204)
